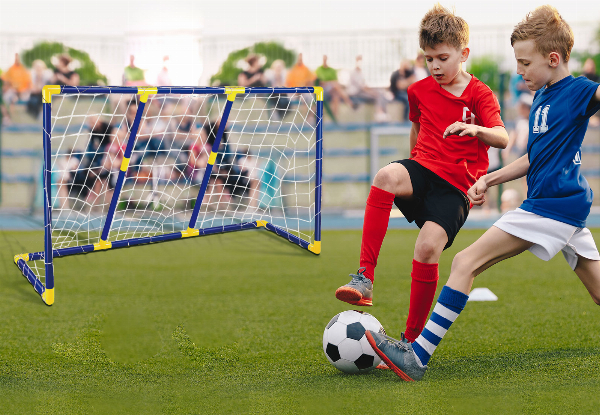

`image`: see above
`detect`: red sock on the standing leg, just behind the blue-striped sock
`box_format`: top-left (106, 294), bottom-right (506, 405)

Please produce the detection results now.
top-left (404, 259), bottom-right (439, 343)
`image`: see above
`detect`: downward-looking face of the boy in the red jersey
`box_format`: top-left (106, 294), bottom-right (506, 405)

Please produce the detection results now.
top-left (424, 43), bottom-right (469, 85)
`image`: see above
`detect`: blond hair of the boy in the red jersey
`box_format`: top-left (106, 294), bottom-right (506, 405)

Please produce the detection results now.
top-left (419, 3), bottom-right (469, 50)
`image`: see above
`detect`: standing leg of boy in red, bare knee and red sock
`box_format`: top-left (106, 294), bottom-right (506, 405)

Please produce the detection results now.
top-left (404, 221), bottom-right (448, 343)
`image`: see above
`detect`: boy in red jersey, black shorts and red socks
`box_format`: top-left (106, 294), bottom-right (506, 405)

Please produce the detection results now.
top-left (335, 4), bottom-right (508, 342)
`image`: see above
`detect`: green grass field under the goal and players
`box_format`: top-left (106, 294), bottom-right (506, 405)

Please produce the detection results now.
top-left (0, 230), bottom-right (600, 414)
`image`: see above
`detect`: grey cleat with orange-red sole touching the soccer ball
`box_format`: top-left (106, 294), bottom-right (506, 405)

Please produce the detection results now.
top-left (365, 330), bottom-right (427, 382)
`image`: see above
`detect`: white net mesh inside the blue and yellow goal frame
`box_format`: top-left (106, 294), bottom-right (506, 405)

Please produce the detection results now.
top-left (28, 89), bottom-right (317, 283)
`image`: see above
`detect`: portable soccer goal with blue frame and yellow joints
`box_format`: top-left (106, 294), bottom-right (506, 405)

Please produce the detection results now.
top-left (14, 86), bottom-right (323, 305)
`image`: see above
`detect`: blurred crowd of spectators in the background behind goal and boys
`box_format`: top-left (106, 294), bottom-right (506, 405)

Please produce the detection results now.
top-left (0, 48), bottom-right (600, 214)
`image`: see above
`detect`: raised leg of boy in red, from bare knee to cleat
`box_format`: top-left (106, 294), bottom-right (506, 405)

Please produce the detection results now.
top-left (335, 163), bottom-right (413, 305)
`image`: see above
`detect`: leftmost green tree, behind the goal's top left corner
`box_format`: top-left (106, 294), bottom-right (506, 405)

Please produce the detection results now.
top-left (20, 42), bottom-right (107, 85)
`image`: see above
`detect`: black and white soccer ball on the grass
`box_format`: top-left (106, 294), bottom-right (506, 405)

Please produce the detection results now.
top-left (323, 310), bottom-right (385, 373)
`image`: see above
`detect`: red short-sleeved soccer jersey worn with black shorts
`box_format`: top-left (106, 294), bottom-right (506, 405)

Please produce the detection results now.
top-left (408, 76), bottom-right (504, 194)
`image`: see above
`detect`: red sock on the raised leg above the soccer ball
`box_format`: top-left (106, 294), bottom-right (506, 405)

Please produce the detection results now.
top-left (360, 186), bottom-right (395, 282)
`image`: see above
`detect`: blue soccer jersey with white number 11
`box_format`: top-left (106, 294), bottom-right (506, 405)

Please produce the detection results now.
top-left (521, 76), bottom-right (600, 227)
